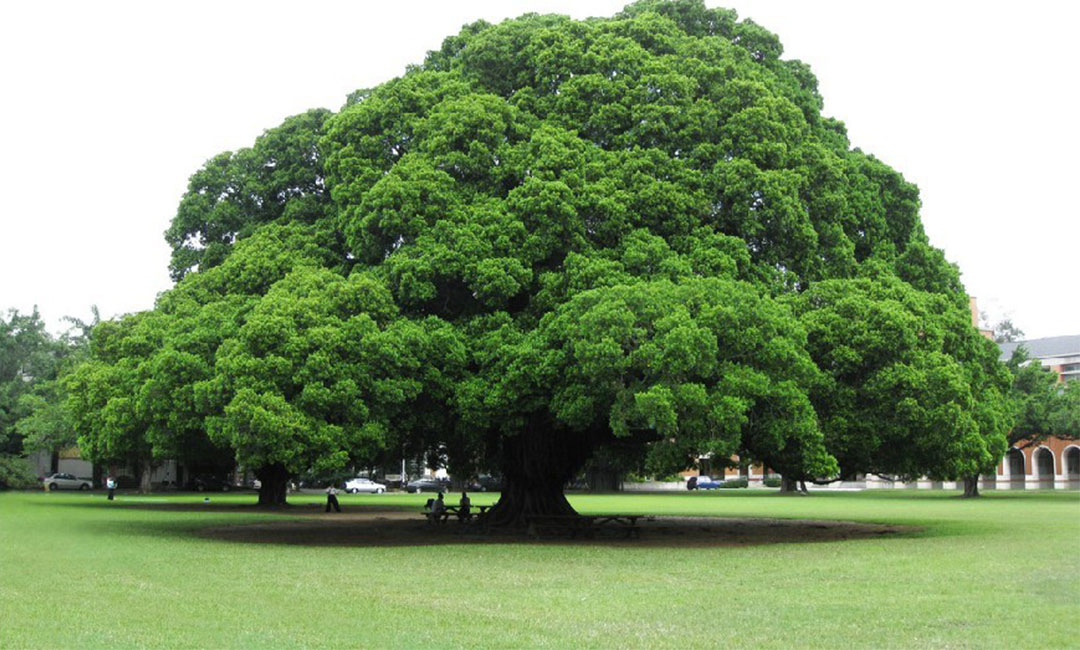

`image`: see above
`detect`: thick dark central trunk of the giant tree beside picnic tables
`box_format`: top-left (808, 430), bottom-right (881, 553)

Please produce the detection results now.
top-left (485, 425), bottom-right (592, 527)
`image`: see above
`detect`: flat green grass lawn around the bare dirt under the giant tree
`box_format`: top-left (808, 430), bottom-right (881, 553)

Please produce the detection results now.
top-left (0, 490), bottom-right (1080, 650)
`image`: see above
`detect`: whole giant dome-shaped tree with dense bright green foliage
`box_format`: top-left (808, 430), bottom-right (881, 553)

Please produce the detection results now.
top-left (65, 0), bottom-right (1004, 511)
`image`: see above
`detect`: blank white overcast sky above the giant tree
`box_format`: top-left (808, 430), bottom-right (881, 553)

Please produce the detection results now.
top-left (0, 0), bottom-right (1080, 338)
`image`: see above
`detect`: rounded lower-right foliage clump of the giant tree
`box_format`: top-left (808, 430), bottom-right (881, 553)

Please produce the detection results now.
top-left (791, 275), bottom-right (1011, 480)
